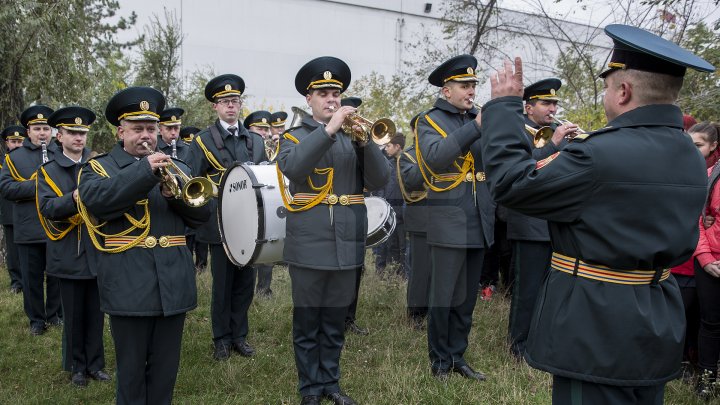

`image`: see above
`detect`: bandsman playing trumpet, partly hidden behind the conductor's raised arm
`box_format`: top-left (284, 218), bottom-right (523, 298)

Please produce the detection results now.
top-left (507, 78), bottom-right (577, 360)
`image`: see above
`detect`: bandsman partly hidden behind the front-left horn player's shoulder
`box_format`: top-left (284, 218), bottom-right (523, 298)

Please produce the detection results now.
top-left (37, 107), bottom-right (110, 387)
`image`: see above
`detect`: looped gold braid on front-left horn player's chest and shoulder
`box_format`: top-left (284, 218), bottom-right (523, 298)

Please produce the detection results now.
top-left (77, 160), bottom-right (150, 253)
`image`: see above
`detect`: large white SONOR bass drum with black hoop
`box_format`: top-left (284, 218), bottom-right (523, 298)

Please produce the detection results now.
top-left (218, 163), bottom-right (287, 266)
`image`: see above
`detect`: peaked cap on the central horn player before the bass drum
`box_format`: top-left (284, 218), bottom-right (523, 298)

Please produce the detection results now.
top-left (295, 56), bottom-right (351, 96)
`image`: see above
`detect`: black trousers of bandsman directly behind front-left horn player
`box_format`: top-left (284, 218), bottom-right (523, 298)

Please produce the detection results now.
top-left (60, 278), bottom-right (105, 373)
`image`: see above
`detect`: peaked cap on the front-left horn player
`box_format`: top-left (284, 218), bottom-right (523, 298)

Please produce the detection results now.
top-left (105, 87), bottom-right (165, 126)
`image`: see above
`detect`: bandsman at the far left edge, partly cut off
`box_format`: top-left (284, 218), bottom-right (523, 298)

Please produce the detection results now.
top-left (0, 125), bottom-right (27, 294)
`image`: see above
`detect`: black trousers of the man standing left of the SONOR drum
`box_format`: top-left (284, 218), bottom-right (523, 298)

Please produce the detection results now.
top-left (210, 245), bottom-right (255, 345)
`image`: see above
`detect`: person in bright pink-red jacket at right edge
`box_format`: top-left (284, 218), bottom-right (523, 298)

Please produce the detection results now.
top-left (688, 123), bottom-right (720, 397)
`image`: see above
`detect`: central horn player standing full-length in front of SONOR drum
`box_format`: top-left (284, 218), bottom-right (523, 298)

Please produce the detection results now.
top-left (277, 56), bottom-right (388, 405)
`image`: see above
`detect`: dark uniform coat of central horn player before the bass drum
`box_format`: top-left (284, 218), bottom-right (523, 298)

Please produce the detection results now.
top-left (277, 117), bottom-right (389, 270)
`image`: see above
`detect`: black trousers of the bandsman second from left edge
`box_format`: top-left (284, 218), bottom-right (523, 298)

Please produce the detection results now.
top-left (16, 243), bottom-right (62, 327)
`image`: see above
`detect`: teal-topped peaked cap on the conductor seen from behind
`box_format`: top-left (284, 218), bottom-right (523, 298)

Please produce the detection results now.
top-left (600, 24), bottom-right (715, 78)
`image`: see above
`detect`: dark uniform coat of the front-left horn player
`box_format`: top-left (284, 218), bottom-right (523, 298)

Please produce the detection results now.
top-left (78, 143), bottom-right (210, 316)
